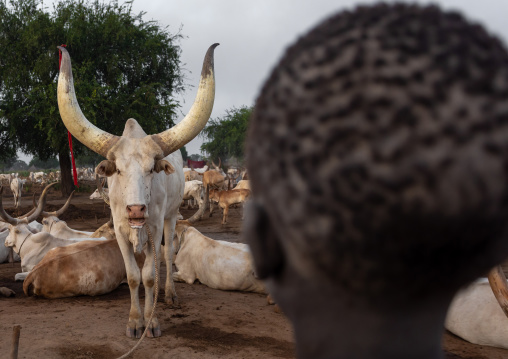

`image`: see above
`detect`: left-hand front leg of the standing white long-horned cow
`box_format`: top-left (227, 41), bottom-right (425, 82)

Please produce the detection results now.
top-left (117, 237), bottom-right (144, 338)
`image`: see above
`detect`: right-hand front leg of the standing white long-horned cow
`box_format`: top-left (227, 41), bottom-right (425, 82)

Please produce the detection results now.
top-left (142, 238), bottom-right (162, 338)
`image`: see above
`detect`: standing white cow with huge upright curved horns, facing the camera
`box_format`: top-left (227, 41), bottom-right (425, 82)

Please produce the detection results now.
top-left (58, 44), bottom-right (218, 338)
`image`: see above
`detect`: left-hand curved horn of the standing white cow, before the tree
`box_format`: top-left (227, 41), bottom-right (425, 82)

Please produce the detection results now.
top-left (57, 46), bottom-right (120, 158)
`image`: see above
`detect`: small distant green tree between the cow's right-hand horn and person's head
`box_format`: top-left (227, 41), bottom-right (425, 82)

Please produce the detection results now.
top-left (199, 106), bottom-right (253, 164)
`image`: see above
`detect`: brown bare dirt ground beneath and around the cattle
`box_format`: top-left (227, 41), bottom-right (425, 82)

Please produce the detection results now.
top-left (0, 183), bottom-right (508, 359)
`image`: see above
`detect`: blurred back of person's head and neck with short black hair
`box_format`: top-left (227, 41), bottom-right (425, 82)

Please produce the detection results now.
top-left (245, 4), bottom-right (508, 358)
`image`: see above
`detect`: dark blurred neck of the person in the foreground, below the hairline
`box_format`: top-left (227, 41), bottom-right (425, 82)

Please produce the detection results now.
top-left (269, 272), bottom-right (453, 359)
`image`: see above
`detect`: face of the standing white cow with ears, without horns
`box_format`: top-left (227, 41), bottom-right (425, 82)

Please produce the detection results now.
top-left (95, 137), bottom-right (174, 229)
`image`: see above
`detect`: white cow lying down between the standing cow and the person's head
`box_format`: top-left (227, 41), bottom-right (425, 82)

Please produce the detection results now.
top-left (173, 221), bottom-right (266, 293)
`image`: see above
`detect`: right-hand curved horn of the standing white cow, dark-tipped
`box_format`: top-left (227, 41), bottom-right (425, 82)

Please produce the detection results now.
top-left (152, 44), bottom-right (219, 156)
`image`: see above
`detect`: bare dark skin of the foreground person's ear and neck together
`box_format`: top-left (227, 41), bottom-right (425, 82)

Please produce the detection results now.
top-left (244, 203), bottom-right (460, 359)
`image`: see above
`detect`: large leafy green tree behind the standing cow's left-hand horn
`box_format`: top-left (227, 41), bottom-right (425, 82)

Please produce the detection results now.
top-left (0, 0), bottom-right (183, 195)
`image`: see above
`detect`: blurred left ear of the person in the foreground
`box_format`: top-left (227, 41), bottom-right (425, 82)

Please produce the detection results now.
top-left (243, 200), bottom-right (284, 279)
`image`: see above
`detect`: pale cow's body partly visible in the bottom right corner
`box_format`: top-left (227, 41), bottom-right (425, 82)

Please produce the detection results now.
top-left (445, 278), bottom-right (508, 349)
